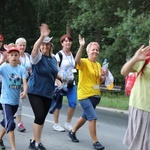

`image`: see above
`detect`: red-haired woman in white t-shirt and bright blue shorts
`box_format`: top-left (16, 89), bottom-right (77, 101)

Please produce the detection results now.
top-left (52, 35), bottom-right (77, 132)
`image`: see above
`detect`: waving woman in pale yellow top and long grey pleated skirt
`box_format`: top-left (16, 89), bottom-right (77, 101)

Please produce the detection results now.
top-left (121, 46), bottom-right (150, 150)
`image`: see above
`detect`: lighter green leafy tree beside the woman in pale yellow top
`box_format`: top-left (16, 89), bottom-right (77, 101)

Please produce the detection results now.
top-left (103, 9), bottom-right (150, 84)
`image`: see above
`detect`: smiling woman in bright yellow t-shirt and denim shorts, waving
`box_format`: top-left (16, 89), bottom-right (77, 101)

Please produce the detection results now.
top-left (69, 35), bottom-right (105, 150)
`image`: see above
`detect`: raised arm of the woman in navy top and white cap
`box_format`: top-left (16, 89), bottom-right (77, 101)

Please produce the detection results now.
top-left (31, 23), bottom-right (50, 58)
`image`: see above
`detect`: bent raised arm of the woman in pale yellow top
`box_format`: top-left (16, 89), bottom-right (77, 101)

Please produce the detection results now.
top-left (121, 45), bottom-right (150, 76)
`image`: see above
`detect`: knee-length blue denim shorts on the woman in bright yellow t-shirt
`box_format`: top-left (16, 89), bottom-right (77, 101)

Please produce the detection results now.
top-left (79, 97), bottom-right (101, 121)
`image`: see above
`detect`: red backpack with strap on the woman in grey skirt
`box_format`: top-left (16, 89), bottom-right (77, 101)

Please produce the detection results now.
top-left (125, 54), bottom-right (150, 96)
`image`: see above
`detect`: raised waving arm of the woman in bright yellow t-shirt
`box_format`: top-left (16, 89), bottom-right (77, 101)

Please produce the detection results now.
top-left (75, 34), bottom-right (85, 65)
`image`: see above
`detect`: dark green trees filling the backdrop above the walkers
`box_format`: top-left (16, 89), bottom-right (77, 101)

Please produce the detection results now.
top-left (0, 0), bottom-right (150, 85)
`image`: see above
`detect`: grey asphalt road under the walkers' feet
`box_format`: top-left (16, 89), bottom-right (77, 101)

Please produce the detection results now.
top-left (3, 100), bottom-right (128, 150)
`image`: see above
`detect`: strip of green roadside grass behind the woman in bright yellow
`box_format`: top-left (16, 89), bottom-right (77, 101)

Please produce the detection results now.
top-left (99, 93), bottom-right (129, 110)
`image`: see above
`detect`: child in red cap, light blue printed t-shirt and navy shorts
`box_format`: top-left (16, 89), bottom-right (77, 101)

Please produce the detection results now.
top-left (0, 44), bottom-right (27, 150)
